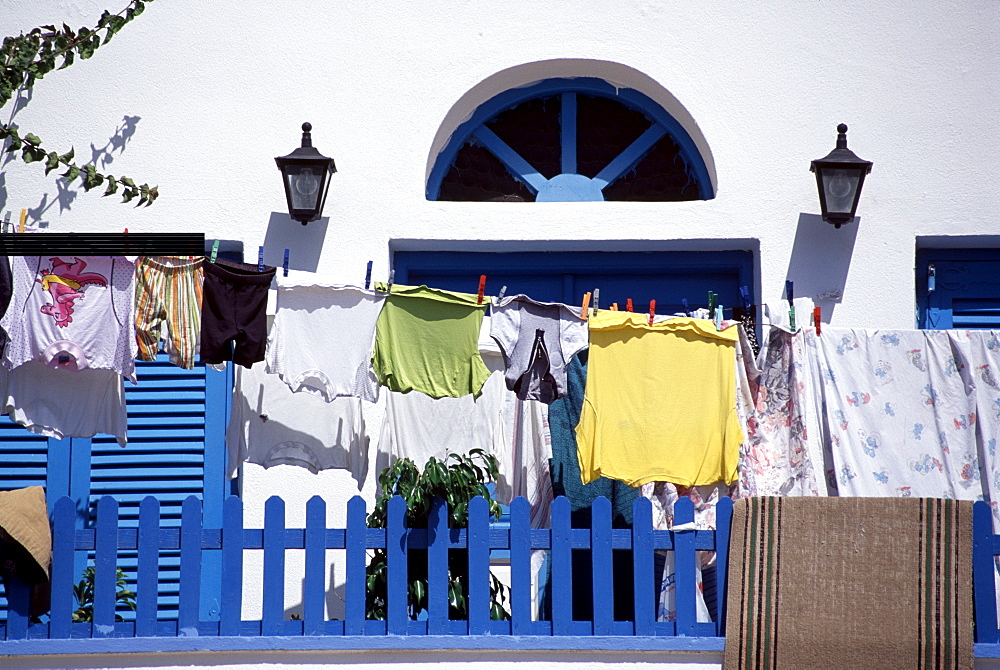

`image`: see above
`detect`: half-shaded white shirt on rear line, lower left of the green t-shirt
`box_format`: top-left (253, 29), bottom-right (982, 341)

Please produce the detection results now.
top-left (226, 365), bottom-right (368, 487)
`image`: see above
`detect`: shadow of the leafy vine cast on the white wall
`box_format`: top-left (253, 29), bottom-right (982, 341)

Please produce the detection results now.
top-left (0, 110), bottom-right (144, 227)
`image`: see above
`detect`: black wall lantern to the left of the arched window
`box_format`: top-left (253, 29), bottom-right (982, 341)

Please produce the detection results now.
top-left (274, 123), bottom-right (337, 226)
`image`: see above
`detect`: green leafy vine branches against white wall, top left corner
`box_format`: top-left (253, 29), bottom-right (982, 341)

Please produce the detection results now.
top-left (0, 0), bottom-right (159, 206)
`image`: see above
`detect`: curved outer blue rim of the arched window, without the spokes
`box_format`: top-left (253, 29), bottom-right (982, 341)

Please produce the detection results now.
top-left (426, 77), bottom-right (716, 201)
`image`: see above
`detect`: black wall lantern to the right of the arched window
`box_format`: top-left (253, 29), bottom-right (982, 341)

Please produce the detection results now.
top-left (809, 123), bottom-right (872, 228)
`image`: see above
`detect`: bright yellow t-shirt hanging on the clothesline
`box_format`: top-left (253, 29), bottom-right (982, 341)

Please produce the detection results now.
top-left (576, 310), bottom-right (743, 486)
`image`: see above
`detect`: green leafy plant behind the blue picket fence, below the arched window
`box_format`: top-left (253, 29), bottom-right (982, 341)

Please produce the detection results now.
top-left (366, 449), bottom-right (510, 620)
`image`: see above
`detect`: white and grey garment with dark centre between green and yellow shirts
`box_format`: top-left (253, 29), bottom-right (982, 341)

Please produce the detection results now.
top-left (490, 295), bottom-right (587, 403)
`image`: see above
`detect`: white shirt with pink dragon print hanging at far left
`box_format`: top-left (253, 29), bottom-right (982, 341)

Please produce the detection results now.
top-left (0, 256), bottom-right (137, 384)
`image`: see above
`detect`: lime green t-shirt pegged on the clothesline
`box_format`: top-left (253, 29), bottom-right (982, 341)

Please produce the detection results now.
top-left (372, 283), bottom-right (490, 398)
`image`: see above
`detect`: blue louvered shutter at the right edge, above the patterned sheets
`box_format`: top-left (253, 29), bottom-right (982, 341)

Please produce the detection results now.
top-left (916, 249), bottom-right (1000, 328)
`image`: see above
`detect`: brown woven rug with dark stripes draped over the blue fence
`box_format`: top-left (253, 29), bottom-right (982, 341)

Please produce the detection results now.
top-left (724, 497), bottom-right (973, 670)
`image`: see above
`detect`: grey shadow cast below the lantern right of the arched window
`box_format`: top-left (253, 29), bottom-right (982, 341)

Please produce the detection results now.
top-left (785, 214), bottom-right (861, 323)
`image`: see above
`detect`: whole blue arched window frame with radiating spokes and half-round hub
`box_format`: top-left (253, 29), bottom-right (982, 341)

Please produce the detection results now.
top-left (426, 77), bottom-right (715, 202)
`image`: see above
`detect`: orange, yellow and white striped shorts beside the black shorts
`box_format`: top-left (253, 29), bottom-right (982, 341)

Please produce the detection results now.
top-left (135, 256), bottom-right (204, 370)
